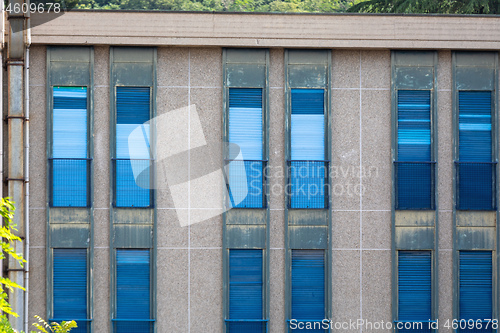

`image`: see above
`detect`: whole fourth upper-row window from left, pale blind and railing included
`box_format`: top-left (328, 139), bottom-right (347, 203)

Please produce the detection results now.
top-left (288, 89), bottom-right (328, 208)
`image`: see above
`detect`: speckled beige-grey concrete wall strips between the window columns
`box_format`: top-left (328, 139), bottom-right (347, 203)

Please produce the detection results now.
top-left (29, 42), bottom-right (460, 333)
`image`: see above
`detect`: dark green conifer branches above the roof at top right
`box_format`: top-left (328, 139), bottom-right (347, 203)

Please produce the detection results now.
top-left (348, 0), bottom-right (500, 14)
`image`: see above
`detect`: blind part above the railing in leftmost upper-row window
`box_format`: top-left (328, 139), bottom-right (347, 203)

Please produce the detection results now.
top-left (52, 87), bottom-right (88, 158)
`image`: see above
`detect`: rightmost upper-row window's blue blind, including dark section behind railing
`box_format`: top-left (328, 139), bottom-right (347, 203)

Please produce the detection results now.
top-left (457, 91), bottom-right (495, 210)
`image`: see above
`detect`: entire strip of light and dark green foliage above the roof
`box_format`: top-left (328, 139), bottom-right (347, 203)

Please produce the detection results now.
top-left (74, 0), bottom-right (500, 14)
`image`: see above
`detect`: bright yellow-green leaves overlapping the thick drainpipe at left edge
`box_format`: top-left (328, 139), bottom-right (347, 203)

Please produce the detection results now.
top-left (0, 198), bottom-right (26, 317)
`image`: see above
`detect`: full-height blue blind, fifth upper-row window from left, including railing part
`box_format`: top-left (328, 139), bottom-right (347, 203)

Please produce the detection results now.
top-left (395, 90), bottom-right (434, 209)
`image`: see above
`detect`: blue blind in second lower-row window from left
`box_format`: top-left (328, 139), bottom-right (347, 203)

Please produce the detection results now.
top-left (114, 249), bottom-right (153, 333)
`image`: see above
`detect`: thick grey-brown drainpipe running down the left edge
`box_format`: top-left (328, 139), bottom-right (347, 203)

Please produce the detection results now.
top-left (6, 0), bottom-right (29, 331)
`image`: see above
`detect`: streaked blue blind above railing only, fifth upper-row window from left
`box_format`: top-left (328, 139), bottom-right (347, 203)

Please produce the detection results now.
top-left (398, 90), bottom-right (431, 162)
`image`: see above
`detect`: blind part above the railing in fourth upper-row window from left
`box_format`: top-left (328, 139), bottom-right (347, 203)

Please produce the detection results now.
top-left (290, 89), bottom-right (325, 161)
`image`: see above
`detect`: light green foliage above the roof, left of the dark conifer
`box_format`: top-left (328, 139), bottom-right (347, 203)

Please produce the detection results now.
top-left (76, 0), bottom-right (360, 13)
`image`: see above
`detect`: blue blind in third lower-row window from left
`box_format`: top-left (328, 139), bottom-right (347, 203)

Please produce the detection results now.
top-left (226, 249), bottom-right (265, 333)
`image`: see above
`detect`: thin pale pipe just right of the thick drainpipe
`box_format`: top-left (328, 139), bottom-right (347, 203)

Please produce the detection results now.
top-left (24, 11), bottom-right (31, 332)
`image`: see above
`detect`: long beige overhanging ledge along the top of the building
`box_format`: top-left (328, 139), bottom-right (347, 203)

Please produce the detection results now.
top-left (32, 11), bottom-right (500, 50)
